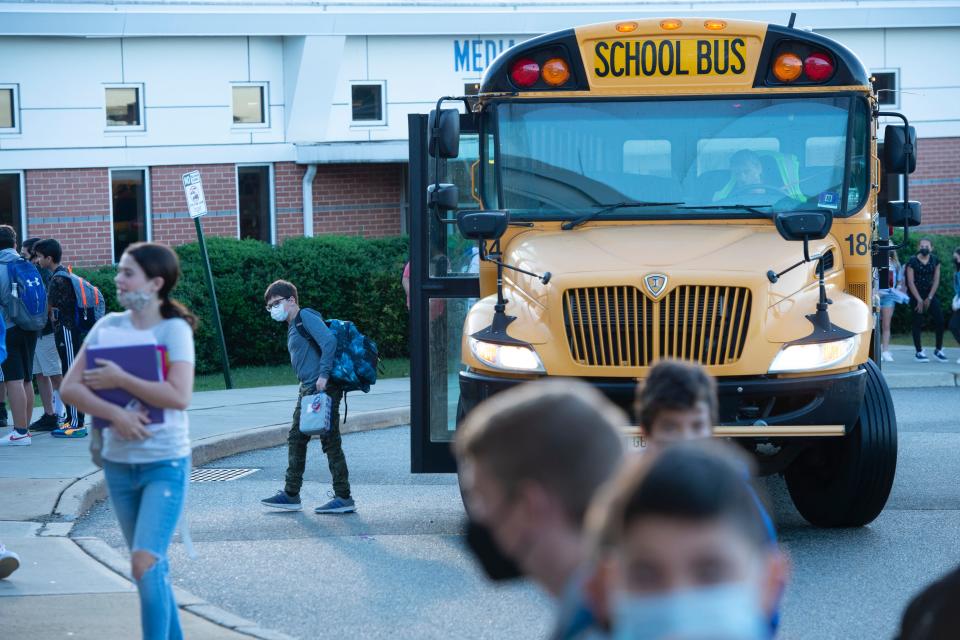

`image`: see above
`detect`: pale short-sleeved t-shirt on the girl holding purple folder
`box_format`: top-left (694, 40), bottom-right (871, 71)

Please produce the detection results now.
top-left (84, 311), bottom-right (195, 464)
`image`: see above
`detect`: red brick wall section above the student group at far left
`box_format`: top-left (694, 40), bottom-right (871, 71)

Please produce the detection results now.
top-left (25, 169), bottom-right (113, 265)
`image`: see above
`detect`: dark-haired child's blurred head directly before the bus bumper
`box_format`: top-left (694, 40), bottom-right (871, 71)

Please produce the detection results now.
top-left (635, 360), bottom-right (717, 449)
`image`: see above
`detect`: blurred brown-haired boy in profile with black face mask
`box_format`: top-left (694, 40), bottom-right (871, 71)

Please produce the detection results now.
top-left (454, 380), bottom-right (627, 639)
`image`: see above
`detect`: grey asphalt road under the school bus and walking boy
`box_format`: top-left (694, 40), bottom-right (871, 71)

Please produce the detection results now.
top-left (74, 388), bottom-right (960, 640)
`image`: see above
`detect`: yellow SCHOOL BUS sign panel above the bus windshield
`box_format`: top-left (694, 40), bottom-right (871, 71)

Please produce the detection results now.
top-left (593, 37), bottom-right (755, 79)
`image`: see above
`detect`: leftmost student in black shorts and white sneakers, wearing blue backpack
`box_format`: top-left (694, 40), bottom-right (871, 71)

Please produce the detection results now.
top-left (0, 224), bottom-right (42, 446)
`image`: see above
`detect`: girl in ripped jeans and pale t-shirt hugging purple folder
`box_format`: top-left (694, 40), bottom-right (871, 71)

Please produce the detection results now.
top-left (61, 242), bottom-right (196, 640)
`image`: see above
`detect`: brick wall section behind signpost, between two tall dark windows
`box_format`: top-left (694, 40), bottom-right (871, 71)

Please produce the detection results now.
top-left (150, 164), bottom-right (238, 245)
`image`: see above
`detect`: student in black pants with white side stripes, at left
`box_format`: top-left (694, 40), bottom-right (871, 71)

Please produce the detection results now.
top-left (40, 239), bottom-right (87, 438)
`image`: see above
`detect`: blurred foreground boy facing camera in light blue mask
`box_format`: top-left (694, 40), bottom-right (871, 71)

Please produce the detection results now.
top-left (588, 441), bottom-right (788, 640)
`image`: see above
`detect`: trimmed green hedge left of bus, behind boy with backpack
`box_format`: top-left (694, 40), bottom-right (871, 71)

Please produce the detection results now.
top-left (76, 236), bottom-right (409, 373)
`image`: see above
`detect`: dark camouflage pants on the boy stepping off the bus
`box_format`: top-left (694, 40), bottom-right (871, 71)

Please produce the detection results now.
top-left (284, 384), bottom-right (350, 498)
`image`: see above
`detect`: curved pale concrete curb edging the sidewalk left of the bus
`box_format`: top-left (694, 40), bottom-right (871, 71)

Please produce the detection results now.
top-left (52, 407), bottom-right (410, 640)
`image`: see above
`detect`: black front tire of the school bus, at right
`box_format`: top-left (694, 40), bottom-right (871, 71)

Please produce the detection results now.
top-left (784, 360), bottom-right (897, 527)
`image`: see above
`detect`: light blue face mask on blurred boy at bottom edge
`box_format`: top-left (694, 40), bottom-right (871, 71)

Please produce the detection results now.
top-left (611, 583), bottom-right (770, 640)
